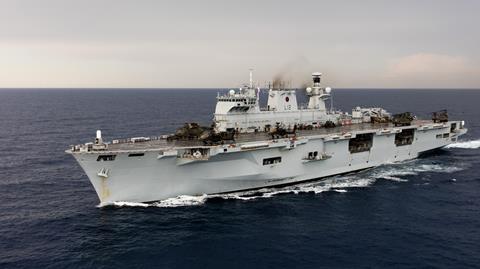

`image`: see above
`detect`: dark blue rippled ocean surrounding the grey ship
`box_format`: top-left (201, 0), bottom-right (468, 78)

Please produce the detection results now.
top-left (0, 89), bottom-right (480, 268)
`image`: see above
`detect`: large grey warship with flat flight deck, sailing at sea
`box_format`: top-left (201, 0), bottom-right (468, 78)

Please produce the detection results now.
top-left (66, 72), bottom-right (467, 204)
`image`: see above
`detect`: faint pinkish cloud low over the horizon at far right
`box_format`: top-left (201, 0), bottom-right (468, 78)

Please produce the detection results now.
top-left (385, 53), bottom-right (480, 87)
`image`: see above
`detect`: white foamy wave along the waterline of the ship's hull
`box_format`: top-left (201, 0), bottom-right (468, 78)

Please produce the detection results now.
top-left (100, 159), bottom-right (463, 208)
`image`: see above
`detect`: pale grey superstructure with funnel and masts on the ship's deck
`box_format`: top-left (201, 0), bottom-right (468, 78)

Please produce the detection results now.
top-left (214, 73), bottom-right (338, 133)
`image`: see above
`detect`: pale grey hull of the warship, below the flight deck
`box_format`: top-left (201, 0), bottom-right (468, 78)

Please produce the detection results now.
top-left (70, 121), bottom-right (466, 203)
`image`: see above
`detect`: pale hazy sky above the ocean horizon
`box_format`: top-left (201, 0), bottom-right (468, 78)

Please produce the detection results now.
top-left (0, 0), bottom-right (480, 88)
